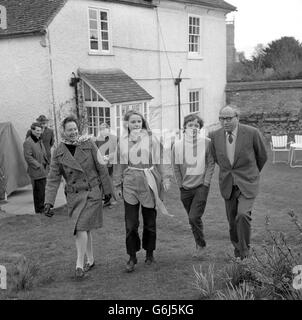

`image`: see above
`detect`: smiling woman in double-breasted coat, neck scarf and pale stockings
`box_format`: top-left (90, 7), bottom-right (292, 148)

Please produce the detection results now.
top-left (45, 117), bottom-right (113, 279)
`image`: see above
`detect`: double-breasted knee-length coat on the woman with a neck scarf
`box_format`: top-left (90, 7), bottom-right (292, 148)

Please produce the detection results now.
top-left (45, 140), bottom-right (113, 234)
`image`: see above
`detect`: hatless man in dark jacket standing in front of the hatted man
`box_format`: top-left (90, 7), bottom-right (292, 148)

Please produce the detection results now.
top-left (23, 122), bottom-right (49, 213)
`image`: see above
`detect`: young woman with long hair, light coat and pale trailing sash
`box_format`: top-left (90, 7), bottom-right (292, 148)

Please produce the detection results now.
top-left (113, 110), bottom-right (172, 272)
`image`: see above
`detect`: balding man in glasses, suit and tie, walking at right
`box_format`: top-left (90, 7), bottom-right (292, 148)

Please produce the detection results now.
top-left (210, 106), bottom-right (267, 259)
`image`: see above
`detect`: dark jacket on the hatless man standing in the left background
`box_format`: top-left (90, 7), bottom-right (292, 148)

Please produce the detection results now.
top-left (23, 136), bottom-right (49, 180)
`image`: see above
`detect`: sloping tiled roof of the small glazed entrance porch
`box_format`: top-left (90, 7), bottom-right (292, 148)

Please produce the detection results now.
top-left (78, 69), bottom-right (153, 104)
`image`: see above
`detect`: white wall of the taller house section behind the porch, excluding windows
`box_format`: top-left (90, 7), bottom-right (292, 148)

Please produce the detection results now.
top-left (49, 0), bottom-right (226, 129)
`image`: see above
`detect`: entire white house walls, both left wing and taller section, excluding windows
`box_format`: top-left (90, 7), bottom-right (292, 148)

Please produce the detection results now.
top-left (0, 0), bottom-right (226, 136)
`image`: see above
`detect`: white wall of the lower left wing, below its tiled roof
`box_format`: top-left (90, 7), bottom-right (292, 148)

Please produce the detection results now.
top-left (0, 37), bottom-right (51, 140)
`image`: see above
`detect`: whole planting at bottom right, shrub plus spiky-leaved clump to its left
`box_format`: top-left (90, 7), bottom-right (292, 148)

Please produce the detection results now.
top-left (194, 211), bottom-right (302, 300)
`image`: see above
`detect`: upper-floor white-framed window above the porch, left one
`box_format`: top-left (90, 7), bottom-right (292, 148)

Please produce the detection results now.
top-left (89, 8), bottom-right (110, 54)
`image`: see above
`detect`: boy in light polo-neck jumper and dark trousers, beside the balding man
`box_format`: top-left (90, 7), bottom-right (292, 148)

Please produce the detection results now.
top-left (172, 114), bottom-right (215, 257)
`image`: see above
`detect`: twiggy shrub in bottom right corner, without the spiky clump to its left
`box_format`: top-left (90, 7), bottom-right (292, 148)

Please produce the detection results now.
top-left (222, 214), bottom-right (301, 300)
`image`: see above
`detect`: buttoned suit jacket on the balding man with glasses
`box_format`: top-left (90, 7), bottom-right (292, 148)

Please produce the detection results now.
top-left (210, 124), bottom-right (267, 199)
